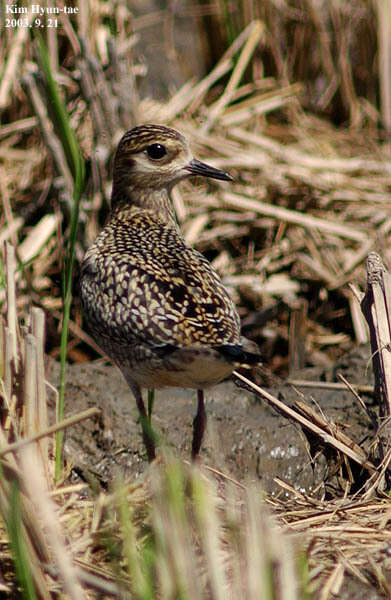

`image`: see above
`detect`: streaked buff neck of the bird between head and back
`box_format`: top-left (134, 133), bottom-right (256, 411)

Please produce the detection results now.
top-left (111, 187), bottom-right (179, 231)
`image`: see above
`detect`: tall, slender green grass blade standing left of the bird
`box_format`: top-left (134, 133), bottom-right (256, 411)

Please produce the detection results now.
top-left (37, 35), bottom-right (85, 479)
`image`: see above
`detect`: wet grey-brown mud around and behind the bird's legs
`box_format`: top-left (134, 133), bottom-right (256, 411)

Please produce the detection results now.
top-left (49, 347), bottom-right (372, 494)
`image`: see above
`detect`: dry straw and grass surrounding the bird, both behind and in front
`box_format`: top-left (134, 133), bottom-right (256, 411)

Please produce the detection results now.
top-left (0, 0), bottom-right (391, 600)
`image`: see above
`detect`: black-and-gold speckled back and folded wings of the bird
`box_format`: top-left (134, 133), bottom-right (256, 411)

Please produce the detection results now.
top-left (82, 224), bottom-right (240, 346)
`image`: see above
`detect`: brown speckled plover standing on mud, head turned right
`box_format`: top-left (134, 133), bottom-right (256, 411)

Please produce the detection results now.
top-left (79, 124), bottom-right (261, 462)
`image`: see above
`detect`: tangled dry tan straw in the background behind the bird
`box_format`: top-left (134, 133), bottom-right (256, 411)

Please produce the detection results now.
top-left (0, 0), bottom-right (391, 374)
